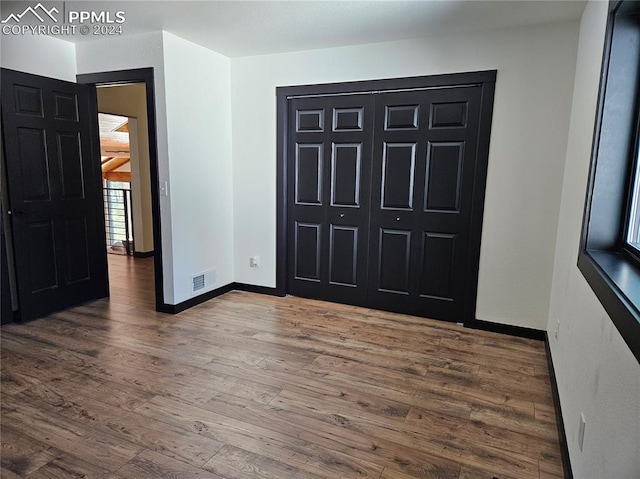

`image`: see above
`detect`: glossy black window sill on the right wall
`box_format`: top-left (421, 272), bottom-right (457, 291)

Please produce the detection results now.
top-left (578, 250), bottom-right (640, 362)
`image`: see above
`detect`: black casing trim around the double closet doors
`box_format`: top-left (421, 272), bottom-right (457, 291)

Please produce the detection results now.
top-left (275, 70), bottom-right (497, 325)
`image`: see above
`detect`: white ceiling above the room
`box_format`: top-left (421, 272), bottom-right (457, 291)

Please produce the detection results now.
top-left (1, 0), bottom-right (585, 57)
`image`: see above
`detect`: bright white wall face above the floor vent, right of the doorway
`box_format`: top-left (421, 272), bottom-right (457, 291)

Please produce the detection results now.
top-left (162, 32), bottom-right (234, 302)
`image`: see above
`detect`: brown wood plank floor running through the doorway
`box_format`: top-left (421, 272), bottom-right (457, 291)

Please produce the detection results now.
top-left (1, 256), bottom-right (562, 479)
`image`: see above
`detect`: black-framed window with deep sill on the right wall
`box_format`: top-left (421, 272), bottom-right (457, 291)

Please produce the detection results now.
top-left (578, 0), bottom-right (640, 362)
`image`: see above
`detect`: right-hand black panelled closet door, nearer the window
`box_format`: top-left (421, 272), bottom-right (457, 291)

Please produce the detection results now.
top-left (368, 86), bottom-right (481, 321)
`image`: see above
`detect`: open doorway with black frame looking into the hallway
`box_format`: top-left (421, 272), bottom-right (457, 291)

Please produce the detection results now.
top-left (77, 68), bottom-right (167, 311)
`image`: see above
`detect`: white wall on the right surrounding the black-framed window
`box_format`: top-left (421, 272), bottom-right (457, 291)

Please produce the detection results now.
top-left (548, 2), bottom-right (640, 479)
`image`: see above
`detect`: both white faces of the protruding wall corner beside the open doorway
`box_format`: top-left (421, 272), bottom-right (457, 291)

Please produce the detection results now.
top-left (77, 32), bottom-right (234, 304)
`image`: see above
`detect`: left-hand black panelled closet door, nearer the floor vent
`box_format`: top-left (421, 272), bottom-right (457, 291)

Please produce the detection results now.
top-left (287, 95), bottom-right (374, 304)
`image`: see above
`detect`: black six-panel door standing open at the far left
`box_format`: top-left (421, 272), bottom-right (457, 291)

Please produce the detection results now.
top-left (1, 69), bottom-right (108, 320)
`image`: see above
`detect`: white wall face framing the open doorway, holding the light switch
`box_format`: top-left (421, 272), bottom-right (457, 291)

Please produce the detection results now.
top-left (76, 32), bottom-right (175, 304)
